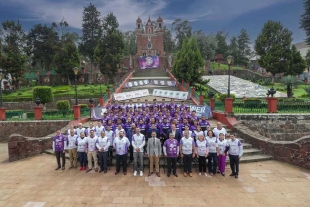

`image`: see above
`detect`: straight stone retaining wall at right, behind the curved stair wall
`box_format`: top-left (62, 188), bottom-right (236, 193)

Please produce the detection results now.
top-left (234, 114), bottom-right (310, 141)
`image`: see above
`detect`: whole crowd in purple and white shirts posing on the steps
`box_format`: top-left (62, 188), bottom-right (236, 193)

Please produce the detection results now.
top-left (53, 99), bottom-right (243, 178)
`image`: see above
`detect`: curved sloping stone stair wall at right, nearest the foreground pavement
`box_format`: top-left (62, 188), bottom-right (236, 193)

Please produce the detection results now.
top-left (233, 124), bottom-right (310, 169)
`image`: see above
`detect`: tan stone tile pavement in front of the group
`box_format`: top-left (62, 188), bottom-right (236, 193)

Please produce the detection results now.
top-left (0, 144), bottom-right (310, 207)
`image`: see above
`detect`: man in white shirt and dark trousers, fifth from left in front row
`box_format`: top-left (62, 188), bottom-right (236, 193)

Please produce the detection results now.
top-left (96, 131), bottom-right (110, 173)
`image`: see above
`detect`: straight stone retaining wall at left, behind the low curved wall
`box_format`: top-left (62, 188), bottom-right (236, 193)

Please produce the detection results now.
top-left (0, 121), bottom-right (69, 142)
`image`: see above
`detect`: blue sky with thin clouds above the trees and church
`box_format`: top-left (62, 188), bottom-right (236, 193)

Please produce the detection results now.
top-left (0, 0), bottom-right (305, 43)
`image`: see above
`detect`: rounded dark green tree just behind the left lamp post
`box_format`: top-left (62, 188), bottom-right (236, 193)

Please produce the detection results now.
top-left (54, 41), bottom-right (80, 85)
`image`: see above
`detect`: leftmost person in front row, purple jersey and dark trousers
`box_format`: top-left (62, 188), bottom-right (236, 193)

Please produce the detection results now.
top-left (53, 130), bottom-right (67, 170)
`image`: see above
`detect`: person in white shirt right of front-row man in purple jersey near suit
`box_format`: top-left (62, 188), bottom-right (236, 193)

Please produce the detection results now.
top-left (180, 132), bottom-right (195, 177)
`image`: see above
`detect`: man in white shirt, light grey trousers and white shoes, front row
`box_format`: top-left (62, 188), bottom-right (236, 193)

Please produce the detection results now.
top-left (131, 128), bottom-right (145, 177)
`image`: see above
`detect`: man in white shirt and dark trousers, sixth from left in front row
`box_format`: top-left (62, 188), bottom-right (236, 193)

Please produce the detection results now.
top-left (113, 131), bottom-right (130, 175)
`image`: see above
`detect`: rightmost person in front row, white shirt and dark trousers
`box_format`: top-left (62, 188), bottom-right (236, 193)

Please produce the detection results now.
top-left (225, 133), bottom-right (243, 178)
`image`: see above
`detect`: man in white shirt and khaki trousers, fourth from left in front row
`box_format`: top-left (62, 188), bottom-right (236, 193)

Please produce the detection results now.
top-left (85, 130), bottom-right (98, 173)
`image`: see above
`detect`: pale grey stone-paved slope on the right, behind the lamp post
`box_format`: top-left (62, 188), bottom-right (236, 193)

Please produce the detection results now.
top-left (203, 75), bottom-right (286, 98)
